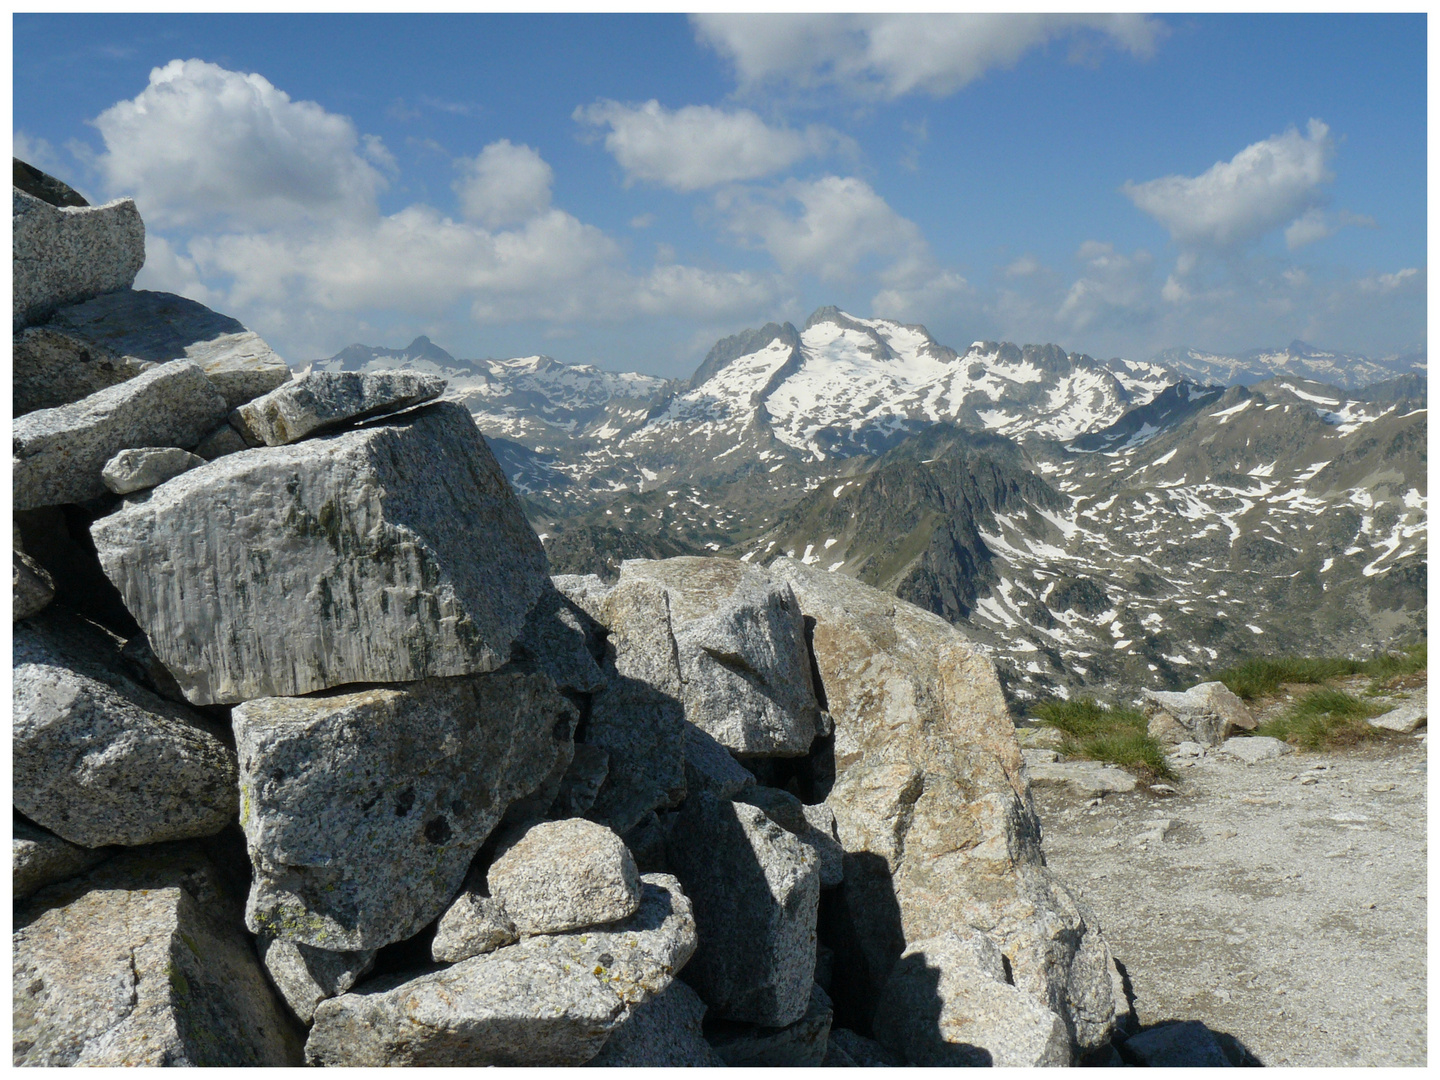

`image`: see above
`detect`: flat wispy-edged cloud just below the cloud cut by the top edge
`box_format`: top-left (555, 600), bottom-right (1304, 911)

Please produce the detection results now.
top-left (575, 101), bottom-right (847, 192)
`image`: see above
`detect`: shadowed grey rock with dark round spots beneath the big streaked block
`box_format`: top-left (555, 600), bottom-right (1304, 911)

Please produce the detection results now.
top-left (232, 668), bottom-right (575, 952)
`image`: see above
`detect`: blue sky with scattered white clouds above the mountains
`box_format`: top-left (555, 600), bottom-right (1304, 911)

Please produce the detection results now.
top-left (14, 14), bottom-right (1427, 376)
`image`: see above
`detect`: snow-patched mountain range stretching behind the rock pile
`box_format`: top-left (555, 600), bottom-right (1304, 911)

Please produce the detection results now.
top-left (315, 308), bottom-right (1427, 698)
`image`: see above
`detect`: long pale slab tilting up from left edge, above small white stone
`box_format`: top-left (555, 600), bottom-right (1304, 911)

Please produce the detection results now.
top-left (12, 360), bottom-right (225, 510)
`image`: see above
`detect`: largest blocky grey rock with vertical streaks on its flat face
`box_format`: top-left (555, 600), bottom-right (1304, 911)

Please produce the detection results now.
top-left (91, 403), bottom-right (546, 705)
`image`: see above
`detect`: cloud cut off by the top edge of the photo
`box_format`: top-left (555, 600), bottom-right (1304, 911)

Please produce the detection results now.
top-left (691, 13), bottom-right (1168, 98)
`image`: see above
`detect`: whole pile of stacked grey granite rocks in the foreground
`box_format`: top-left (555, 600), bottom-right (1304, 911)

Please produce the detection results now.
top-left (13, 163), bottom-right (1123, 1066)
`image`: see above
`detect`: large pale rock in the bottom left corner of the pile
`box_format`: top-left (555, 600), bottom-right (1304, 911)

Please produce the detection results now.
top-left (13, 845), bottom-right (301, 1067)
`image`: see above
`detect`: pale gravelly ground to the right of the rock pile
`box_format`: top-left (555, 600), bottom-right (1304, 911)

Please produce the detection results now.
top-left (1034, 732), bottom-right (1427, 1066)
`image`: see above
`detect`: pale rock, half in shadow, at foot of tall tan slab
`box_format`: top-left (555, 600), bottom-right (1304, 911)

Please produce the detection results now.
top-left (876, 927), bottom-right (1071, 1068)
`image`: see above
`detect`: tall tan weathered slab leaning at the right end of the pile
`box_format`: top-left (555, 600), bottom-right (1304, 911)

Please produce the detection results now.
top-left (770, 559), bottom-right (1115, 1047)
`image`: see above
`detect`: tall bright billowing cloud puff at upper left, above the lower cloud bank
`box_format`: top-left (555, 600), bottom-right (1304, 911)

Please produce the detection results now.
top-left (94, 60), bottom-right (395, 226)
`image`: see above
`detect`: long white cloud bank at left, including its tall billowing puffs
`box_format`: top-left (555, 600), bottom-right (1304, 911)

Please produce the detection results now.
top-left (87, 60), bottom-right (783, 356)
